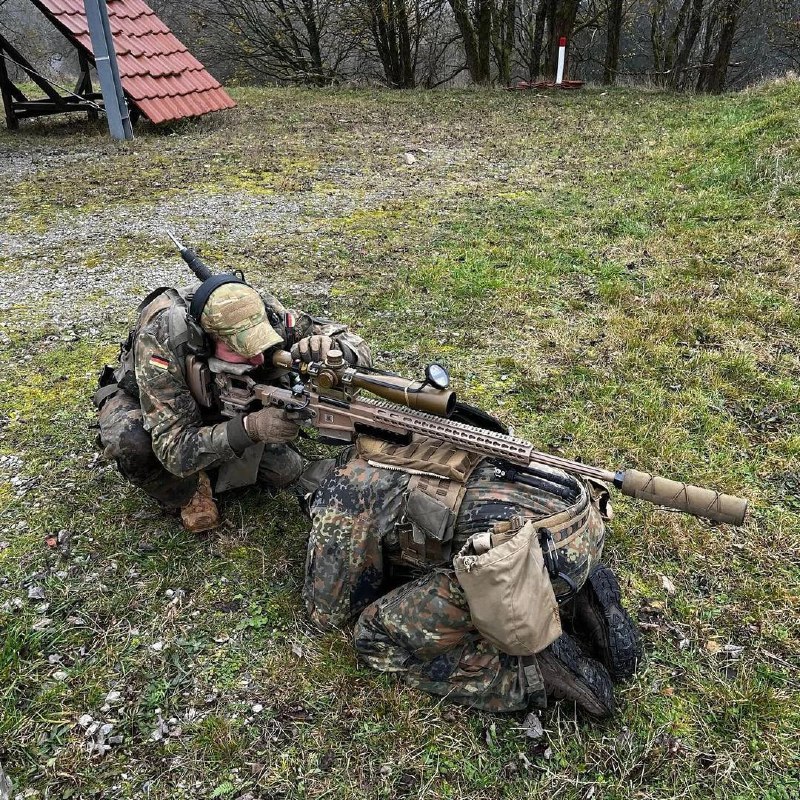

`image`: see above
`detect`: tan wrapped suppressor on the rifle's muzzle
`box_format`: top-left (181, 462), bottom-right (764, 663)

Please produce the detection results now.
top-left (614, 469), bottom-right (747, 525)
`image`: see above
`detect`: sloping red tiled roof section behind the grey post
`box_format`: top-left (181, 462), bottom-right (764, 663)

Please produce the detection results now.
top-left (33, 0), bottom-right (236, 123)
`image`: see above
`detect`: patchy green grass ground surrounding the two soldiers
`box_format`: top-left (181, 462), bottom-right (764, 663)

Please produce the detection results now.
top-left (0, 82), bottom-right (800, 800)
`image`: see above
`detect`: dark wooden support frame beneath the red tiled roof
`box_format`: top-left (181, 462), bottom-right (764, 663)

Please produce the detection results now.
top-left (0, 35), bottom-right (103, 130)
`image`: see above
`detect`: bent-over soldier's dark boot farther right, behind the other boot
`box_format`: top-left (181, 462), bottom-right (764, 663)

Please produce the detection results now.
top-left (562, 564), bottom-right (643, 681)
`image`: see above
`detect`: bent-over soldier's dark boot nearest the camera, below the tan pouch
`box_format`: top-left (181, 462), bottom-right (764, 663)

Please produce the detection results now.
top-left (536, 633), bottom-right (615, 717)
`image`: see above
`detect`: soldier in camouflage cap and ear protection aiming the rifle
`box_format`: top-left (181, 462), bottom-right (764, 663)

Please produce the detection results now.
top-left (94, 274), bottom-right (370, 532)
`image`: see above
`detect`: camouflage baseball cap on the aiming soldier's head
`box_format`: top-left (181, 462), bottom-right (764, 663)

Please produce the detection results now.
top-left (200, 283), bottom-right (283, 358)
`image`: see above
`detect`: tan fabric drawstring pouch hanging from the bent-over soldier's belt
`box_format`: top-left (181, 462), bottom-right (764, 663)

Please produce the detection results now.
top-left (453, 519), bottom-right (561, 656)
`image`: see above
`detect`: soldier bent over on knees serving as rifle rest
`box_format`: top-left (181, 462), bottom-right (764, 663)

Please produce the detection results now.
top-left (304, 437), bottom-right (642, 716)
